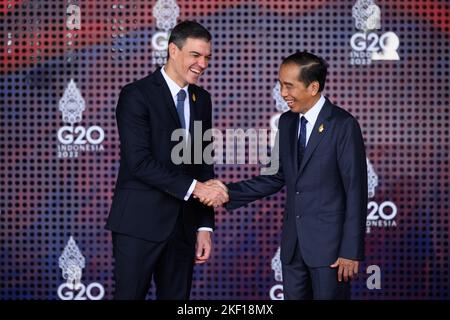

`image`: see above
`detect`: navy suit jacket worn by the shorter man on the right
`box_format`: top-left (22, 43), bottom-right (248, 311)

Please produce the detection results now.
top-left (226, 99), bottom-right (367, 267)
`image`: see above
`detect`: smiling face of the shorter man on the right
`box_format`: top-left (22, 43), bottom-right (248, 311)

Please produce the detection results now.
top-left (279, 63), bottom-right (320, 114)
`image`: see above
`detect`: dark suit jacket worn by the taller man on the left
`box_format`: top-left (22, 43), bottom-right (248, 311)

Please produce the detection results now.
top-left (106, 69), bottom-right (214, 241)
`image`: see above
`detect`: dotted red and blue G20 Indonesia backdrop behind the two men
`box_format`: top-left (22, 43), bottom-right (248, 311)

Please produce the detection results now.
top-left (0, 0), bottom-right (450, 299)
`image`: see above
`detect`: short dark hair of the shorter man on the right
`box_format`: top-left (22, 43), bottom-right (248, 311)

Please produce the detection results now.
top-left (281, 51), bottom-right (328, 92)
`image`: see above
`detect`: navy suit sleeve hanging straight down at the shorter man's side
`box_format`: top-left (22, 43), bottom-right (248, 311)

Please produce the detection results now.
top-left (338, 118), bottom-right (367, 260)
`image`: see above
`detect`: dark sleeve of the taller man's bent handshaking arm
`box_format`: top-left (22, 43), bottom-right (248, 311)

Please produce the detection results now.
top-left (116, 86), bottom-right (193, 200)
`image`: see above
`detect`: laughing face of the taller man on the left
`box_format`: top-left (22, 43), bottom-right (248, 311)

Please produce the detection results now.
top-left (169, 38), bottom-right (211, 87)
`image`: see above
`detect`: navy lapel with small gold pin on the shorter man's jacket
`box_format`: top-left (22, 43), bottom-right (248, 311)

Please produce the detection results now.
top-left (297, 99), bottom-right (332, 178)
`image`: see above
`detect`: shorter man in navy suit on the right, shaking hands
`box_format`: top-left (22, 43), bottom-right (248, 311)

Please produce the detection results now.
top-left (208, 52), bottom-right (367, 299)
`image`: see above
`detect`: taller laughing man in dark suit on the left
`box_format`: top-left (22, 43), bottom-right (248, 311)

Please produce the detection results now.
top-left (106, 21), bottom-right (228, 300)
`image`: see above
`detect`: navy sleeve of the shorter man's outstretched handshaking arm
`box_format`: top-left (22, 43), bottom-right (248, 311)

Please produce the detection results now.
top-left (225, 131), bottom-right (285, 210)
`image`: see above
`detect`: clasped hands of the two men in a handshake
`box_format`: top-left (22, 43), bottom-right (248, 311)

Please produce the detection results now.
top-left (192, 179), bottom-right (230, 208)
